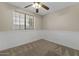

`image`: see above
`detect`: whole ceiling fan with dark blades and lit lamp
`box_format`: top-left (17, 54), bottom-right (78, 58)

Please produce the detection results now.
top-left (24, 2), bottom-right (49, 13)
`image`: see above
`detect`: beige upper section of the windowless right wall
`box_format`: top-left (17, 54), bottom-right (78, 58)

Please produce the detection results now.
top-left (43, 5), bottom-right (79, 31)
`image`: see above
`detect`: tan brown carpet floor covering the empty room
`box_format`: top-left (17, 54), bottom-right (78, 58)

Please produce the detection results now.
top-left (0, 39), bottom-right (79, 56)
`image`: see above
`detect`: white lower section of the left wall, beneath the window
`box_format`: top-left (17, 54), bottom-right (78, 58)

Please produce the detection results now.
top-left (0, 30), bottom-right (43, 51)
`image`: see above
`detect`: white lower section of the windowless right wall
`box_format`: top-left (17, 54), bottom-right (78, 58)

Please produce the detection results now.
top-left (43, 30), bottom-right (79, 50)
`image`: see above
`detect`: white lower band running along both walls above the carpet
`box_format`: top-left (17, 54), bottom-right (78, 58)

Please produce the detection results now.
top-left (0, 30), bottom-right (79, 50)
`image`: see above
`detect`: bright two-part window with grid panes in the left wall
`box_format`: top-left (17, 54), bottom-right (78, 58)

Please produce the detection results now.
top-left (13, 12), bottom-right (34, 30)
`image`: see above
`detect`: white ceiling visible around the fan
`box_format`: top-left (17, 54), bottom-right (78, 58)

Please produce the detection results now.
top-left (8, 2), bottom-right (78, 15)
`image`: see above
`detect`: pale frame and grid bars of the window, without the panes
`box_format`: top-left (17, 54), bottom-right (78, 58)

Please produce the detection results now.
top-left (12, 11), bottom-right (35, 30)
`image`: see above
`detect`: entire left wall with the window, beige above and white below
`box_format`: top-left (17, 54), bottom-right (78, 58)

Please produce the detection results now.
top-left (0, 3), bottom-right (42, 50)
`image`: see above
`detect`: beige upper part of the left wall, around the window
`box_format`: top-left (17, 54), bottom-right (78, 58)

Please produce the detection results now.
top-left (0, 3), bottom-right (42, 31)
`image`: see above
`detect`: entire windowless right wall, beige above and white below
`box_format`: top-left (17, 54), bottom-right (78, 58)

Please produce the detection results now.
top-left (43, 5), bottom-right (79, 50)
